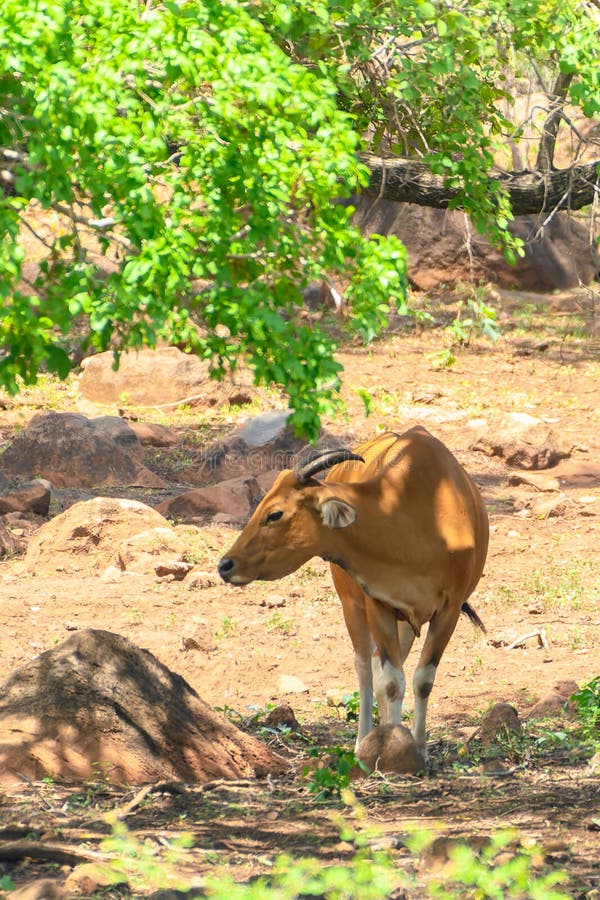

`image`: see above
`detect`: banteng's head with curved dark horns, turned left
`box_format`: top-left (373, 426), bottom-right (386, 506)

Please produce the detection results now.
top-left (219, 449), bottom-right (364, 585)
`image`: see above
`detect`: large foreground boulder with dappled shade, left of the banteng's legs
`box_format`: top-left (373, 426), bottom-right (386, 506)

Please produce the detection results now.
top-left (0, 629), bottom-right (287, 785)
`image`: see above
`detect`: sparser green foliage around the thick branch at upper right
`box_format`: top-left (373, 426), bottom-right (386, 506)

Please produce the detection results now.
top-left (257, 0), bottom-right (600, 250)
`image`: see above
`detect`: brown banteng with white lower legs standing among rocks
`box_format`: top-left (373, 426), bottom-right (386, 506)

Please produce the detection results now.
top-left (219, 427), bottom-right (488, 753)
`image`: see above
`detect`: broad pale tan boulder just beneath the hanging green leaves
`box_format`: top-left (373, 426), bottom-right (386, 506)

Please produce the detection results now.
top-left (79, 347), bottom-right (252, 409)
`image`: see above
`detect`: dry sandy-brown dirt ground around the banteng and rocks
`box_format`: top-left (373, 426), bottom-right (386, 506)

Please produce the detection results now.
top-left (0, 292), bottom-right (600, 898)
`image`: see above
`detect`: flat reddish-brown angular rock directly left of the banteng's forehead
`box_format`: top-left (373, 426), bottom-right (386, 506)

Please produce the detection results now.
top-left (156, 476), bottom-right (263, 524)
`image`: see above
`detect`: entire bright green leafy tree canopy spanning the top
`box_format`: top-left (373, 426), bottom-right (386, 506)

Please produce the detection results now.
top-left (0, 0), bottom-right (600, 437)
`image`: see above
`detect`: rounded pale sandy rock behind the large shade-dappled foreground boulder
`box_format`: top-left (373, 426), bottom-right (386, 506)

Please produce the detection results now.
top-left (17, 497), bottom-right (172, 572)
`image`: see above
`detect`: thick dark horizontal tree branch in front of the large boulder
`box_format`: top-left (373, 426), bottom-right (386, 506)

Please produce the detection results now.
top-left (361, 153), bottom-right (600, 216)
